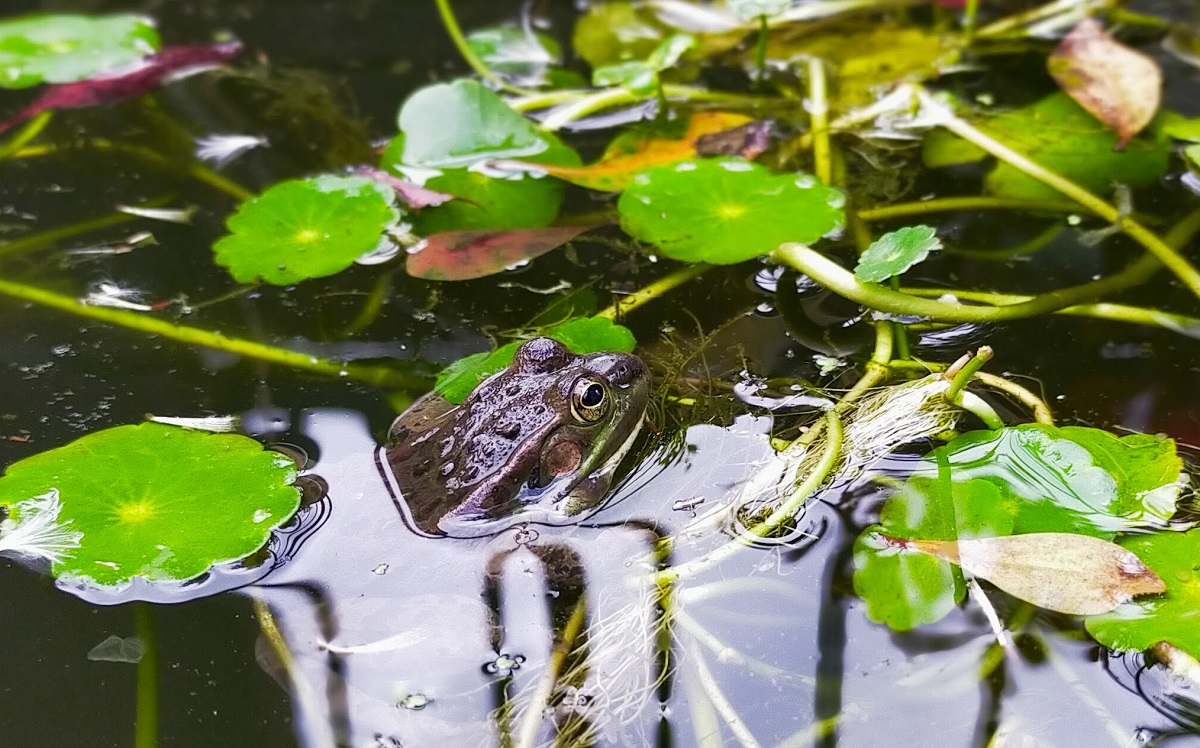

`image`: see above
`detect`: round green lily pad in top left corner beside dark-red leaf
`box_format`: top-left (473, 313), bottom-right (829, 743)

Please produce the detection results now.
top-left (0, 13), bottom-right (160, 89)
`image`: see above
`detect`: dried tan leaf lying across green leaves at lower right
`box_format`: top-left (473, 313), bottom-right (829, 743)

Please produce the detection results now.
top-left (880, 532), bottom-right (1166, 616)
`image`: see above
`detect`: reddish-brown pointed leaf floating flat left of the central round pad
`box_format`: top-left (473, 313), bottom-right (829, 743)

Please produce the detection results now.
top-left (404, 225), bottom-right (595, 281)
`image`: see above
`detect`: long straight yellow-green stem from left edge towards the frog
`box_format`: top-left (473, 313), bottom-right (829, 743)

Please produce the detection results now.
top-left (0, 280), bottom-right (428, 389)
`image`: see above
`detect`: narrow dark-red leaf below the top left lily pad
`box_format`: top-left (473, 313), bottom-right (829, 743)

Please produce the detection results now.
top-left (0, 40), bottom-right (242, 132)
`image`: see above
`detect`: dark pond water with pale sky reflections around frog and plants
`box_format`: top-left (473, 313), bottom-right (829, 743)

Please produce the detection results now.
top-left (0, 0), bottom-right (1200, 748)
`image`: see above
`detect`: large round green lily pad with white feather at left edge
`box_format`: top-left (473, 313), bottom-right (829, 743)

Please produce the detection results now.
top-left (0, 423), bottom-right (300, 586)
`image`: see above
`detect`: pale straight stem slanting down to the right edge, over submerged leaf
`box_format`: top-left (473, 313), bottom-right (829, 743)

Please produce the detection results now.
top-left (916, 88), bottom-right (1200, 304)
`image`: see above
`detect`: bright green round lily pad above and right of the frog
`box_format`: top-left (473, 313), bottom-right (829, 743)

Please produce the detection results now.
top-left (618, 158), bottom-right (846, 264)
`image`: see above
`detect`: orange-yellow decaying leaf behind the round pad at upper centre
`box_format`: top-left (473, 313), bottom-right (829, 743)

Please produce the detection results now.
top-left (506, 112), bottom-right (751, 192)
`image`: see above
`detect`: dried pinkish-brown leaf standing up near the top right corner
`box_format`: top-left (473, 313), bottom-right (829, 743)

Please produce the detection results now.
top-left (1048, 18), bottom-right (1163, 150)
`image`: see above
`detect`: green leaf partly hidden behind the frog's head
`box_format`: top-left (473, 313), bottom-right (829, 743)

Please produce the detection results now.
top-left (433, 317), bottom-right (637, 405)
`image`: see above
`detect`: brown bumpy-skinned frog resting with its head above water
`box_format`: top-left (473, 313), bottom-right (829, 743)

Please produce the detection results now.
top-left (380, 337), bottom-right (649, 537)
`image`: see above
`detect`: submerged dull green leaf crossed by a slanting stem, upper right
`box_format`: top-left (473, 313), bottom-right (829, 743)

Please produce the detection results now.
top-left (922, 92), bottom-right (1170, 199)
